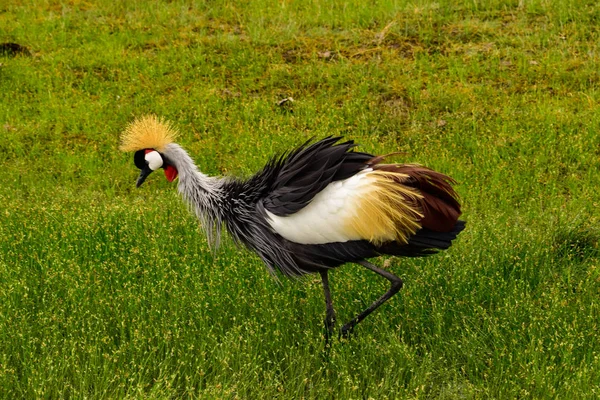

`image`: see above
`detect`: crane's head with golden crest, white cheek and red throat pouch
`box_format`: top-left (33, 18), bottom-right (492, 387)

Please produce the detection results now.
top-left (120, 115), bottom-right (177, 187)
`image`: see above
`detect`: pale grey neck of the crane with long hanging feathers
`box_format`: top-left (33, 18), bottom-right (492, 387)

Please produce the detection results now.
top-left (163, 143), bottom-right (224, 249)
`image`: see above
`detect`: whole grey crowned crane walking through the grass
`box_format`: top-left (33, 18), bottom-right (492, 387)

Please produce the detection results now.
top-left (120, 115), bottom-right (465, 338)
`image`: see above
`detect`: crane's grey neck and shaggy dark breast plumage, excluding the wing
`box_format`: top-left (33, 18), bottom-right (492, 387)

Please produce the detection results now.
top-left (163, 143), bottom-right (354, 277)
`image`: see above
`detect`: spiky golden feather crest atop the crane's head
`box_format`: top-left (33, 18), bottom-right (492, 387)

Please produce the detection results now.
top-left (119, 115), bottom-right (177, 152)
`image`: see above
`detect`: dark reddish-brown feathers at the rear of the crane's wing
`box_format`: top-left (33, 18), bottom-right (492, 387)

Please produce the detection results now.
top-left (372, 162), bottom-right (461, 232)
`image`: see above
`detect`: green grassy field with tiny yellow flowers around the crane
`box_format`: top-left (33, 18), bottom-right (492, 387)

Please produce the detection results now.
top-left (0, 0), bottom-right (600, 399)
